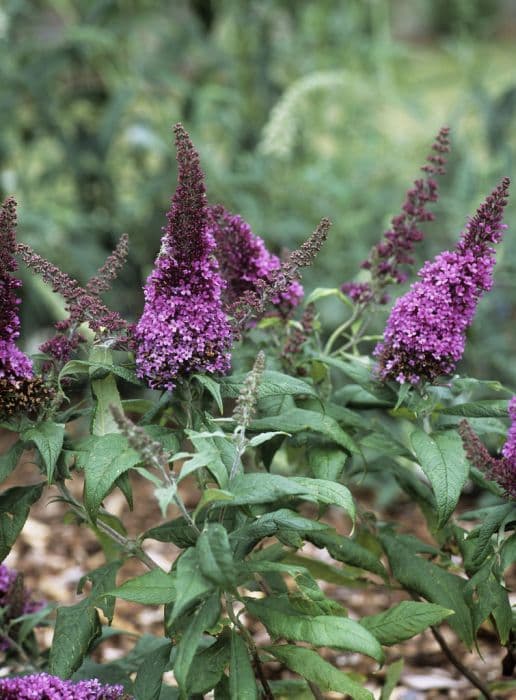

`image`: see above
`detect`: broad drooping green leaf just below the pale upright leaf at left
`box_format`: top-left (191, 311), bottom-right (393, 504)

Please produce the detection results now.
top-left (84, 433), bottom-right (141, 521)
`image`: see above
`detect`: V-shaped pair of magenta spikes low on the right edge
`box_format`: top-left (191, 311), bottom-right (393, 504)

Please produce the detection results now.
top-left (459, 396), bottom-right (516, 499)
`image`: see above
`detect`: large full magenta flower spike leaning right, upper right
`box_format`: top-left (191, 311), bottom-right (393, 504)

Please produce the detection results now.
top-left (374, 178), bottom-right (510, 384)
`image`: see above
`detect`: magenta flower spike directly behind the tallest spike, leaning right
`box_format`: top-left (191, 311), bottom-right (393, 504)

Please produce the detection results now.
top-left (208, 205), bottom-right (303, 315)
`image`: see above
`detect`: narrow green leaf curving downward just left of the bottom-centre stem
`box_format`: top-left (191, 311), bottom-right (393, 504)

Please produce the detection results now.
top-left (174, 592), bottom-right (220, 700)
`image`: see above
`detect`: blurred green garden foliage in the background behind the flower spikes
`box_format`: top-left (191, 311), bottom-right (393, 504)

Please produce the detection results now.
top-left (0, 0), bottom-right (516, 385)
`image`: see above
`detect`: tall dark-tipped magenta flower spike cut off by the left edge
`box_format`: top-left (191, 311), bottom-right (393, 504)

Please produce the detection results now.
top-left (0, 197), bottom-right (33, 387)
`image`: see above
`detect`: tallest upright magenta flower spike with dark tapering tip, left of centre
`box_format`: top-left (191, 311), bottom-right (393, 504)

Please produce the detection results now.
top-left (134, 124), bottom-right (232, 390)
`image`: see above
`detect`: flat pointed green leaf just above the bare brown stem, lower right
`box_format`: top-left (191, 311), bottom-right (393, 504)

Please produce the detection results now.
top-left (360, 600), bottom-right (453, 646)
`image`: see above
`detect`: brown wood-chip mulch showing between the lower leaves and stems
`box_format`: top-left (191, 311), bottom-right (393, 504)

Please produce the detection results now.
top-left (0, 426), bottom-right (515, 700)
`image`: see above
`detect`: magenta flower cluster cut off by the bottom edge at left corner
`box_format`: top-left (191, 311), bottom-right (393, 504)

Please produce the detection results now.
top-left (0, 673), bottom-right (129, 700)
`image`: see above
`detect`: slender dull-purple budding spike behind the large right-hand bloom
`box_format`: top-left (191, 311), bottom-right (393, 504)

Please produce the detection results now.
top-left (341, 126), bottom-right (450, 304)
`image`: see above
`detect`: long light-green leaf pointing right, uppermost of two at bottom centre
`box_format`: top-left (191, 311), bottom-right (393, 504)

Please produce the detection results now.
top-left (245, 597), bottom-right (383, 663)
